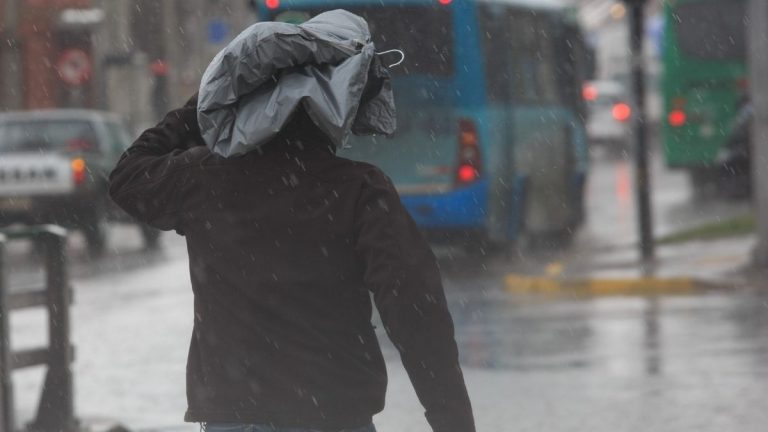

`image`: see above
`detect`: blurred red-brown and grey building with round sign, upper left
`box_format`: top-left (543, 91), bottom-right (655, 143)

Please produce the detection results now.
top-left (0, 0), bottom-right (255, 131)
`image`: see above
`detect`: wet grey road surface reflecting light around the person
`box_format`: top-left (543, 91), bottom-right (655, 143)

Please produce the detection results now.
top-left (11, 152), bottom-right (768, 432)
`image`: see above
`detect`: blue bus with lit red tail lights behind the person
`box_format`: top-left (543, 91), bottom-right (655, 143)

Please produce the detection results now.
top-left (257, 0), bottom-right (588, 251)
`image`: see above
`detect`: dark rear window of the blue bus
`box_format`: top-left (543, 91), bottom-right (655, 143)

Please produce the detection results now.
top-left (271, 6), bottom-right (453, 77)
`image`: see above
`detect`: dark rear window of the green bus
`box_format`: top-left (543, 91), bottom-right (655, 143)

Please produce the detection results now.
top-left (673, 0), bottom-right (746, 61)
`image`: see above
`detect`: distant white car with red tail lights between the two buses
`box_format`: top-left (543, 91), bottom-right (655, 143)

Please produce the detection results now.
top-left (583, 80), bottom-right (632, 150)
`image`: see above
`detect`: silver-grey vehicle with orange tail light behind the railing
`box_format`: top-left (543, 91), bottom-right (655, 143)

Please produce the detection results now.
top-left (0, 109), bottom-right (159, 254)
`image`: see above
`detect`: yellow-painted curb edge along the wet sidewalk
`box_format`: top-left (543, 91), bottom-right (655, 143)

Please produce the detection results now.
top-left (504, 274), bottom-right (699, 296)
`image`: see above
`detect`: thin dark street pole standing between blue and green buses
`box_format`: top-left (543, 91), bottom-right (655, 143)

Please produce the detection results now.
top-left (624, 0), bottom-right (654, 264)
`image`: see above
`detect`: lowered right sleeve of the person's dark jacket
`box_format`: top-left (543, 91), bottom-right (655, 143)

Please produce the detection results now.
top-left (355, 170), bottom-right (475, 432)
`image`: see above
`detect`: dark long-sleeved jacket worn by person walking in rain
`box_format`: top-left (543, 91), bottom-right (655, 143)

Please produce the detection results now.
top-left (110, 100), bottom-right (474, 432)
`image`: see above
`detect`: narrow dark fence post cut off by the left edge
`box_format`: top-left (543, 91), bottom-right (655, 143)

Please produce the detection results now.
top-left (0, 234), bottom-right (16, 431)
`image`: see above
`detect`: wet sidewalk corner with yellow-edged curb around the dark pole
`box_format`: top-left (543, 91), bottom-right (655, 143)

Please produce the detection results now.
top-left (505, 236), bottom-right (754, 295)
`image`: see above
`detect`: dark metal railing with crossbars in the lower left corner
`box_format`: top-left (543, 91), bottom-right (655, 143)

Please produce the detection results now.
top-left (0, 225), bottom-right (78, 432)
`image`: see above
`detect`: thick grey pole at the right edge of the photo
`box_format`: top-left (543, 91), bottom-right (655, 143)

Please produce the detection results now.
top-left (747, 0), bottom-right (768, 268)
